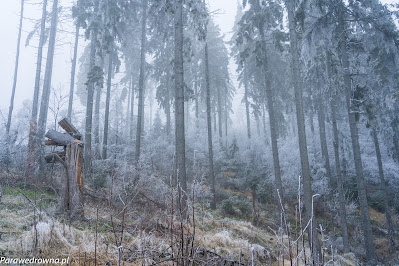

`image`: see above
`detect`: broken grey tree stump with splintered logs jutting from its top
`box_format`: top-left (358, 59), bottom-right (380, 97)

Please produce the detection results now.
top-left (45, 118), bottom-right (84, 220)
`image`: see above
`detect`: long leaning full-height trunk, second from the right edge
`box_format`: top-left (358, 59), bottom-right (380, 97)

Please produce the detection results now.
top-left (338, 2), bottom-right (377, 261)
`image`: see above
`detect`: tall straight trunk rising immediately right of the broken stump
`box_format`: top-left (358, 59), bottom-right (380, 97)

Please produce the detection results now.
top-left (84, 0), bottom-right (99, 180)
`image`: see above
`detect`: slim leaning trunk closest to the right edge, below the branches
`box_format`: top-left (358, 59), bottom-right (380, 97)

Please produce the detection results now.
top-left (371, 127), bottom-right (395, 252)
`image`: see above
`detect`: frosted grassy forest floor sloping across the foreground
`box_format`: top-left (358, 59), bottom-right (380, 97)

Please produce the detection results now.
top-left (0, 175), bottom-right (396, 265)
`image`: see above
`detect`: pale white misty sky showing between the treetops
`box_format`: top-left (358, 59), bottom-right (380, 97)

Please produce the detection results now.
top-left (0, 0), bottom-right (237, 124)
